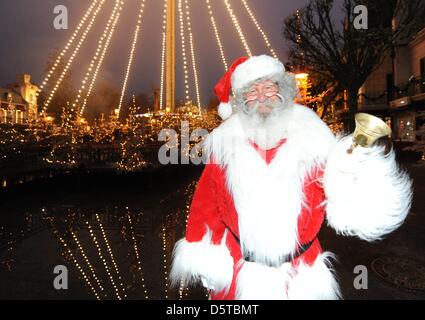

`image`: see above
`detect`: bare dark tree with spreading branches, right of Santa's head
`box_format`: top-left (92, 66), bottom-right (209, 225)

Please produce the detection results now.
top-left (284, 0), bottom-right (425, 131)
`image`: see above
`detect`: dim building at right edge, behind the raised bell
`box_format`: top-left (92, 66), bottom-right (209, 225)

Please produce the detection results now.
top-left (359, 28), bottom-right (425, 144)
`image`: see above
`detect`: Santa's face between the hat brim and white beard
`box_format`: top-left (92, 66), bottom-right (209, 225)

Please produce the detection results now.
top-left (244, 80), bottom-right (280, 118)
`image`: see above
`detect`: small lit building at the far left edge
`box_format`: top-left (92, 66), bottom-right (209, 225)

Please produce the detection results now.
top-left (0, 74), bottom-right (39, 124)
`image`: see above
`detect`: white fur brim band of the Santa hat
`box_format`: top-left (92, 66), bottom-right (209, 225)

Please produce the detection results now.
top-left (232, 55), bottom-right (285, 92)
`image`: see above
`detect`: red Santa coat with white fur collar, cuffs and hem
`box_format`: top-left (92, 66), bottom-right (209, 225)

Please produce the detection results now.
top-left (171, 105), bottom-right (409, 299)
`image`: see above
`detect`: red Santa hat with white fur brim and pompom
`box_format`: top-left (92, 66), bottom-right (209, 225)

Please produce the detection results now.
top-left (214, 55), bottom-right (285, 120)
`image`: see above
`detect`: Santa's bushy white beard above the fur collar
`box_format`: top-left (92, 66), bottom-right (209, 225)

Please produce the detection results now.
top-left (240, 100), bottom-right (293, 150)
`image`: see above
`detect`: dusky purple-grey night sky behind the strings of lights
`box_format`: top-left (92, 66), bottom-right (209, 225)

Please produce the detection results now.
top-left (0, 0), bottom-right (318, 104)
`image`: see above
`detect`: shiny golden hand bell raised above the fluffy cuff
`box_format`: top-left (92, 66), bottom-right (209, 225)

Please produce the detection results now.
top-left (347, 113), bottom-right (391, 153)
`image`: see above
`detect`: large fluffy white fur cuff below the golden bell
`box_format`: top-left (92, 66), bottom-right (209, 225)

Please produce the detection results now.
top-left (324, 135), bottom-right (412, 241)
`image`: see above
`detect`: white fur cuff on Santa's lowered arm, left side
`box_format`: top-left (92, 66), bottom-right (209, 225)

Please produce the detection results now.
top-left (170, 231), bottom-right (233, 292)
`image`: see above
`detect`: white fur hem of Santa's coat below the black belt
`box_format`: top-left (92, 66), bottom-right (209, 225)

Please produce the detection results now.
top-left (236, 253), bottom-right (341, 300)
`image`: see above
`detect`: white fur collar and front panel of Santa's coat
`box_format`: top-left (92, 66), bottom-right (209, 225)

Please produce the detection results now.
top-left (205, 105), bottom-right (335, 265)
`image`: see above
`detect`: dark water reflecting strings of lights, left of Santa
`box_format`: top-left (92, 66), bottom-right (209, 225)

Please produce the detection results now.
top-left (0, 172), bottom-right (205, 300)
